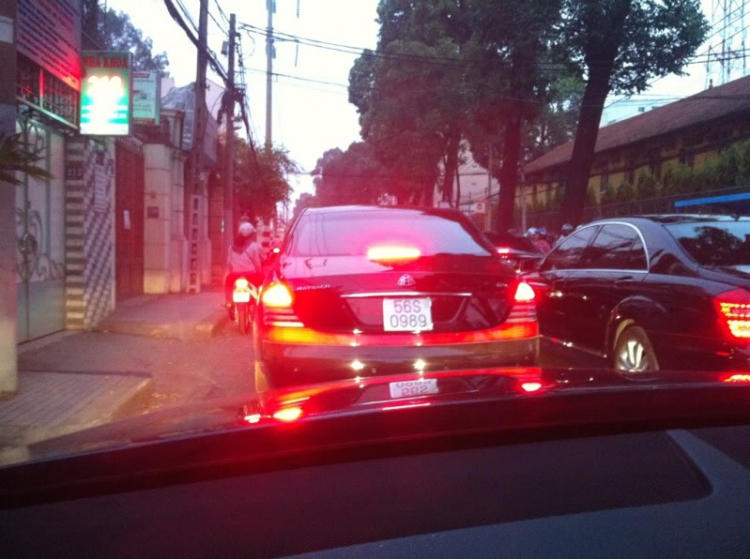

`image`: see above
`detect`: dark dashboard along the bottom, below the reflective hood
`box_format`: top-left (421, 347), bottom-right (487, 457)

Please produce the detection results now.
top-left (0, 426), bottom-right (750, 558)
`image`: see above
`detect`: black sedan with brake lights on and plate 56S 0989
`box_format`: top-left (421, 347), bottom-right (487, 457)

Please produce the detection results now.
top-left (254, 206), bottom-right (538, 391)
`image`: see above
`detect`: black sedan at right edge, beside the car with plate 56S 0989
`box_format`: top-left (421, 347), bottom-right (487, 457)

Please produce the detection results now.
top-left (525, 214), bottom-right (750, 372)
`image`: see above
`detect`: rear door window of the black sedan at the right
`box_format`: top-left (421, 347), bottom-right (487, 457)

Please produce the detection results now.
top-left (581, 224), bottom-right (646, 270)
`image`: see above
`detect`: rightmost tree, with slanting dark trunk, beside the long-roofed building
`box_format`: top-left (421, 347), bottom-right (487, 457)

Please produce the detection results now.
top-left (560, 0), bottom-right (708, 228)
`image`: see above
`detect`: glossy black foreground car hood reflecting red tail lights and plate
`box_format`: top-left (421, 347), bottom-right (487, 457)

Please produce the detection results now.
top-left (5, 368), bottom-right (750, 464)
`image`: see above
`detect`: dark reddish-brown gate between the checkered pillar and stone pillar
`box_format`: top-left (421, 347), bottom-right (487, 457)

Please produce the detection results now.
top-left (115, 140), bottom-right (145, 299)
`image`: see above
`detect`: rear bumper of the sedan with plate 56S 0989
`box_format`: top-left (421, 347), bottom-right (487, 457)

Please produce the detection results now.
top-left (256, 336), bottom-right (539, 388)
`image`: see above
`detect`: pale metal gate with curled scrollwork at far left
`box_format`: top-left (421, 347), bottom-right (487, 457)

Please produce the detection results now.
top-left (16, 117), bottom-right (65, 342)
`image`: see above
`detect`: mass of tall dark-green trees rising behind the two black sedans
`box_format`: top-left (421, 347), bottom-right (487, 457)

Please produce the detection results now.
top-left (319, 0), bottom-right (708, 230)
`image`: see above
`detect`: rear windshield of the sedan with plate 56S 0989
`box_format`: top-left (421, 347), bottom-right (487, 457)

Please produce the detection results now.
top-left (288, 211), bottom-right (493, 256)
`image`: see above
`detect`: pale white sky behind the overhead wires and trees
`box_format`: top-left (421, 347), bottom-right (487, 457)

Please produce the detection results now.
top-left (104, 0), bottom-right (750, 202)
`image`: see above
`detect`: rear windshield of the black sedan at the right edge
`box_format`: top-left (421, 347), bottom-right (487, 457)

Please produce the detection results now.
top-left (665, 221), bottom-right (750, 266)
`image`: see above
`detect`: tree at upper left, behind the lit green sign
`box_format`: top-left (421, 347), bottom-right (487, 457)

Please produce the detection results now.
top-left (81, 0), bottom-right (169, 77)
